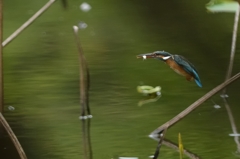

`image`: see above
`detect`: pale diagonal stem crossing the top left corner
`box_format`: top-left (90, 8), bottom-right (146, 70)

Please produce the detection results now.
top-left (2, 0), bottom-right (55, 47)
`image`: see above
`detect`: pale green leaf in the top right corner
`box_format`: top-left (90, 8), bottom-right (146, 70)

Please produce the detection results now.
top-left (206, 0), bottom-right (239, 13)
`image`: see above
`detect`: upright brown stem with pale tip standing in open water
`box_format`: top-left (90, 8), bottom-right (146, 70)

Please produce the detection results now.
top-left (73, 26), bottom-right (91, 117)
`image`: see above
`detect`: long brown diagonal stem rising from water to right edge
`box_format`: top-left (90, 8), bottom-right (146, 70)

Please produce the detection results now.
top-left (151, 72), bottom-right (240, 134)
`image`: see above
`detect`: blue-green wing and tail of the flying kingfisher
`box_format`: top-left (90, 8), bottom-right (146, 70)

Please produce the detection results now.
top-left (173, 55), bottom-right (202, 87)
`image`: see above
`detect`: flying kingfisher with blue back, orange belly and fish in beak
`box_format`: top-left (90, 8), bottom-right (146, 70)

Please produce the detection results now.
top-left (137, 51), bottom-right (202, 87)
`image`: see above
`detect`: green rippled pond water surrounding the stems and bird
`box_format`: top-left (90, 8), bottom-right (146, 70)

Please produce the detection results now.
top-left (0, 0), bottom-right (240, 159)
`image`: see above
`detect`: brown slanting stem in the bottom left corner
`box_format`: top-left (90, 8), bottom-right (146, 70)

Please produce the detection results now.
top-left (0, 113), bottom-right (27, 159)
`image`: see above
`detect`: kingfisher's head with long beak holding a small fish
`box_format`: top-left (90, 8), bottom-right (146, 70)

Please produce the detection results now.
top-left (137, 51), bottom-right (172, 61)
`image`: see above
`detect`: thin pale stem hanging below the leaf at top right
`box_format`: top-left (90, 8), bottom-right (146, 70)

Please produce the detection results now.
top-left (222, 3), bottom-right (240, 94)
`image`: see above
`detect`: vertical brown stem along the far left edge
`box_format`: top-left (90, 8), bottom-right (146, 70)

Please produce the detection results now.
top-left (0, 0), bottom-right (3, 113)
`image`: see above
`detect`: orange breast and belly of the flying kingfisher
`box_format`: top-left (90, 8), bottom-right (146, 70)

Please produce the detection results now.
top-left (166, 58), bottom-right (193, 81)
